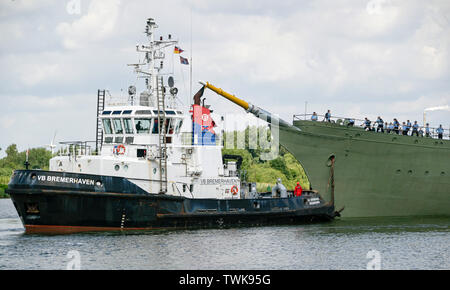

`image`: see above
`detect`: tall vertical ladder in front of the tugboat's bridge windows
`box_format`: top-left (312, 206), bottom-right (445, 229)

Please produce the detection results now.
top-left (156, 76), bottom-right (167, 194)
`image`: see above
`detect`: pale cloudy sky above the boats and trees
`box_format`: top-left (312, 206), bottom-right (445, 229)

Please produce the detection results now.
top-left (0, 0), bottom-right (450, 157)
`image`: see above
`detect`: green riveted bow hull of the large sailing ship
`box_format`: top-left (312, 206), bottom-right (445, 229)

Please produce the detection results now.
top-left (280, 120), bottom-right (450, 217)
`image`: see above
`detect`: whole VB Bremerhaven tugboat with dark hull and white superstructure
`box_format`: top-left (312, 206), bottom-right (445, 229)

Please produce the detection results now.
top-left (7, 18), bottom-right (338, 233)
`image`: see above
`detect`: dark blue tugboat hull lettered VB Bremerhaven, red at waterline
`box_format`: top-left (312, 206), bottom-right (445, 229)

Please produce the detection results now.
top-left (7, 171), bottom-right (335, 233)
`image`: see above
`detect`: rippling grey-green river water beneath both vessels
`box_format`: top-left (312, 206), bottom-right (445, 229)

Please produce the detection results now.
top-left (0, 199), bottom-right (450, 270)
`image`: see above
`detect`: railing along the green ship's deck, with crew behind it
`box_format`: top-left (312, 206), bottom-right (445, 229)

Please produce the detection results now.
top-left (293, 114), bottom-right (450, 140)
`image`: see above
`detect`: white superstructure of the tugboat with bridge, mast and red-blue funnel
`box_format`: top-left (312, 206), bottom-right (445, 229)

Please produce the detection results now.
top-left (50, 19), bottom-right (240, 199)
